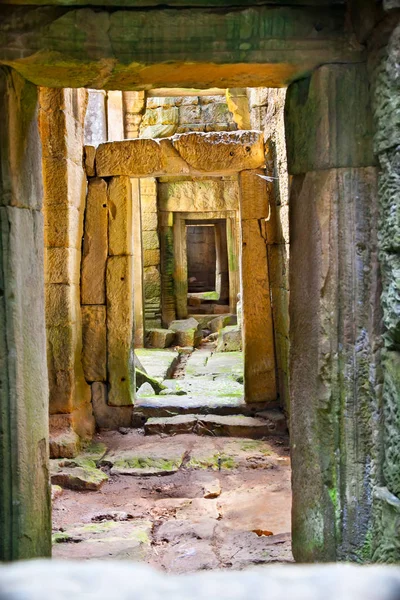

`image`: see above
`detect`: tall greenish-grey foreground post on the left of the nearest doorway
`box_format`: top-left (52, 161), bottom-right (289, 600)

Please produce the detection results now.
top-left (0, 68), bottom-right (51, 561)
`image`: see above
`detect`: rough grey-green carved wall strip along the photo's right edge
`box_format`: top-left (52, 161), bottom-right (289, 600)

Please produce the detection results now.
top-left (369, 14), bottom-right (400, 562)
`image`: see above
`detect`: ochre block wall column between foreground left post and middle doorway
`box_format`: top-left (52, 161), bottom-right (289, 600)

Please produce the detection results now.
top-left (39, 88), bottom-right (97, 457)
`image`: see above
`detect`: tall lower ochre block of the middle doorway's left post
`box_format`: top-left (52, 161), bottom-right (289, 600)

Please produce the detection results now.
top-left (106, 256), bottom-right (135, 406)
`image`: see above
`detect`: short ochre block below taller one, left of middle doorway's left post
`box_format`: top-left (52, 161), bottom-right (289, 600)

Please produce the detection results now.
top-left (82, 305), bottom-right (107, 382)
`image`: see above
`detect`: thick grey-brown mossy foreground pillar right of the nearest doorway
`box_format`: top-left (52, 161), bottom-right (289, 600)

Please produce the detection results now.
top-left (285, 65), bottom-right (379, 562)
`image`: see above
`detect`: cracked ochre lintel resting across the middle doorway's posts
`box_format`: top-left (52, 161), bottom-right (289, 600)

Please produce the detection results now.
top-left (96, 131), bottom-right (264, 177)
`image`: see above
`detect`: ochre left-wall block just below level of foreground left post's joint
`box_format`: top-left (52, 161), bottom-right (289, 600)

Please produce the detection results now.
top-left (44, 206), bottom-right (83, 250)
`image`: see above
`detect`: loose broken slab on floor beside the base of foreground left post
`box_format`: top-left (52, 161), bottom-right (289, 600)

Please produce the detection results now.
top-left (50, 459), bottom-right (108, 491)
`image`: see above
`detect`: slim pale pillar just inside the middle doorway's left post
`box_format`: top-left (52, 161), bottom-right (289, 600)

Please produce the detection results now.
top-left (131, 178), bottom-right (145, 348)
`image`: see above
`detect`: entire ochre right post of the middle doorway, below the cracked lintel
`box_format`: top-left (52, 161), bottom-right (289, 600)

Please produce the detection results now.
top-left (239, 171), bottom-right (276, 402)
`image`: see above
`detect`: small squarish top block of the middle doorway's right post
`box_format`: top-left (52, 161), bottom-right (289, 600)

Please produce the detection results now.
top-left (239, 169), bottom-right (274, 219)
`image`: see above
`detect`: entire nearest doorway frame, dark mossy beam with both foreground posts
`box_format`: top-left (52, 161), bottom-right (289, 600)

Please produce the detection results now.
top-left (0, 2), bottom-right (399, 561)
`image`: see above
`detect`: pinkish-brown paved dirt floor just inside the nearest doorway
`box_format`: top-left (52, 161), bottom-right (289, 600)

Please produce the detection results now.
top-left (53, 429), bottom-right (293, 573)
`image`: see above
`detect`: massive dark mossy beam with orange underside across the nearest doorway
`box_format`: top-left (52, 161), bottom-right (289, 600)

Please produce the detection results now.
top-left (0, 5), bottom-right (365, 90)
